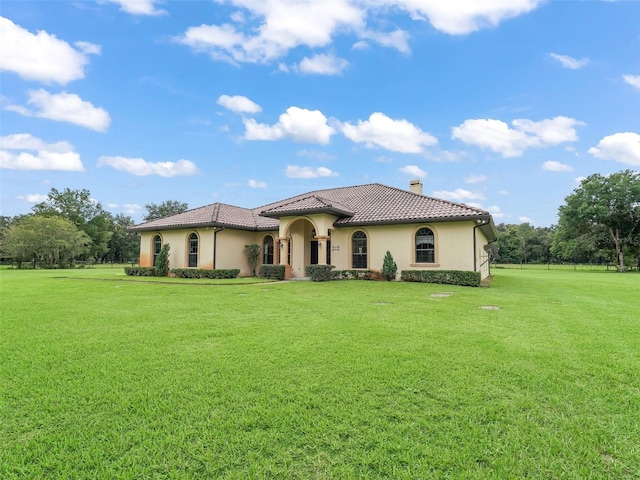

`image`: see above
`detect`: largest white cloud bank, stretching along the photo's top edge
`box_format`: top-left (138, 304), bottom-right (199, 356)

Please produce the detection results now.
top-left (174, 0), bottom-right (543, 65)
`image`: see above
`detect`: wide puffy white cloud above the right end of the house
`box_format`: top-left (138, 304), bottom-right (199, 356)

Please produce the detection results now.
top-left (451, 116), bottom-right (584, 157)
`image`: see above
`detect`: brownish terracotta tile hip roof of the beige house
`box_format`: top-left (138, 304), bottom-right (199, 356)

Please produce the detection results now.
top-left (131, 183), bottom-right (491, 235)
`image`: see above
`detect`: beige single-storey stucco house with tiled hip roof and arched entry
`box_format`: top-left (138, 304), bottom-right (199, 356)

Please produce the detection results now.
top-left (130, 180), bottom-right (497, 278)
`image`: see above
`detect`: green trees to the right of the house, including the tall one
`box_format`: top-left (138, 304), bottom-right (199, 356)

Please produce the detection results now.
top-left (495, 170), bottom-right (640, 271)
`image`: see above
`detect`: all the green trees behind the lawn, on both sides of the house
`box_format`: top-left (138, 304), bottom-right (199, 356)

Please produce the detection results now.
top-left (0, 170), bottom-right (640, 271)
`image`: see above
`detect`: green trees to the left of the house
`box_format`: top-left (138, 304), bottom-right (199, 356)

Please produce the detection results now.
top-left (0, 188), bottom-right (188, 268)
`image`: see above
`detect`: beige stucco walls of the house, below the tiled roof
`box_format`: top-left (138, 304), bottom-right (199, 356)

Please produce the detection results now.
top-left (140, 214), bottom-right (489, 278)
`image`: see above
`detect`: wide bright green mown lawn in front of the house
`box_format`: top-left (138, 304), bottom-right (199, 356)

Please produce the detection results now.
top-left (0, 268), bottom-right (640, 479)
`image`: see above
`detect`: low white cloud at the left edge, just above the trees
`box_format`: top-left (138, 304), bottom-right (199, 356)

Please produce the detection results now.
top-left (0, 133), bottom-right (84, 172)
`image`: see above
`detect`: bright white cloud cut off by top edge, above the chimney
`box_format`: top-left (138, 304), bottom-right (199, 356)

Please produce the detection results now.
top-left (385, 0), bottom-right (542, 35)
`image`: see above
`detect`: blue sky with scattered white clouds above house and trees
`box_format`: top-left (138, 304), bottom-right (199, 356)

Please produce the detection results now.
top-left (0, 0), bottom-right (640, 227)
